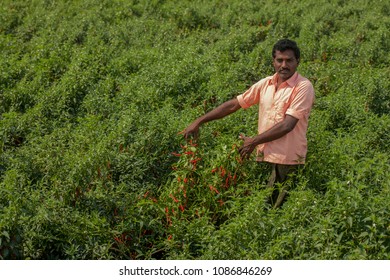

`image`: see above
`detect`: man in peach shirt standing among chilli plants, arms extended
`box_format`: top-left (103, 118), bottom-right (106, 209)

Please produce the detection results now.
top-left (181, 39), bottom-right (314, 208)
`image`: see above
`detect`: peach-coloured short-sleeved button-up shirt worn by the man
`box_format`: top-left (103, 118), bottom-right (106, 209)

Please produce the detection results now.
top-left (237, 72), bottom-right (315, 164)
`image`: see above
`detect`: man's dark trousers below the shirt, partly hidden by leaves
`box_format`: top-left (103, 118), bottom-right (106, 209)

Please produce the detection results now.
top-left (267, 163), bottom-right (301, 208)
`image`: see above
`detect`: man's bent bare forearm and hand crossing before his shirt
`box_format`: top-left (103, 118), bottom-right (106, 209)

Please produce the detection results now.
top-left (239, 115), bottom-right (298, 158)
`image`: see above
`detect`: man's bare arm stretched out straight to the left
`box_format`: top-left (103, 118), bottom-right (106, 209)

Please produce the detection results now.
top-left (180, 98), bottom-right (241, 139)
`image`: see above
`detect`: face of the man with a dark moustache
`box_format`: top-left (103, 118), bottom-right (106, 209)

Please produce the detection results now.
top-left (273, 50), bottom-right (299, 82)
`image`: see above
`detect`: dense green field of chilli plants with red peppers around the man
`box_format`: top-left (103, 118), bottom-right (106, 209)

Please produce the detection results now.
top-left (0, 0), bottom-right (390, 259)
